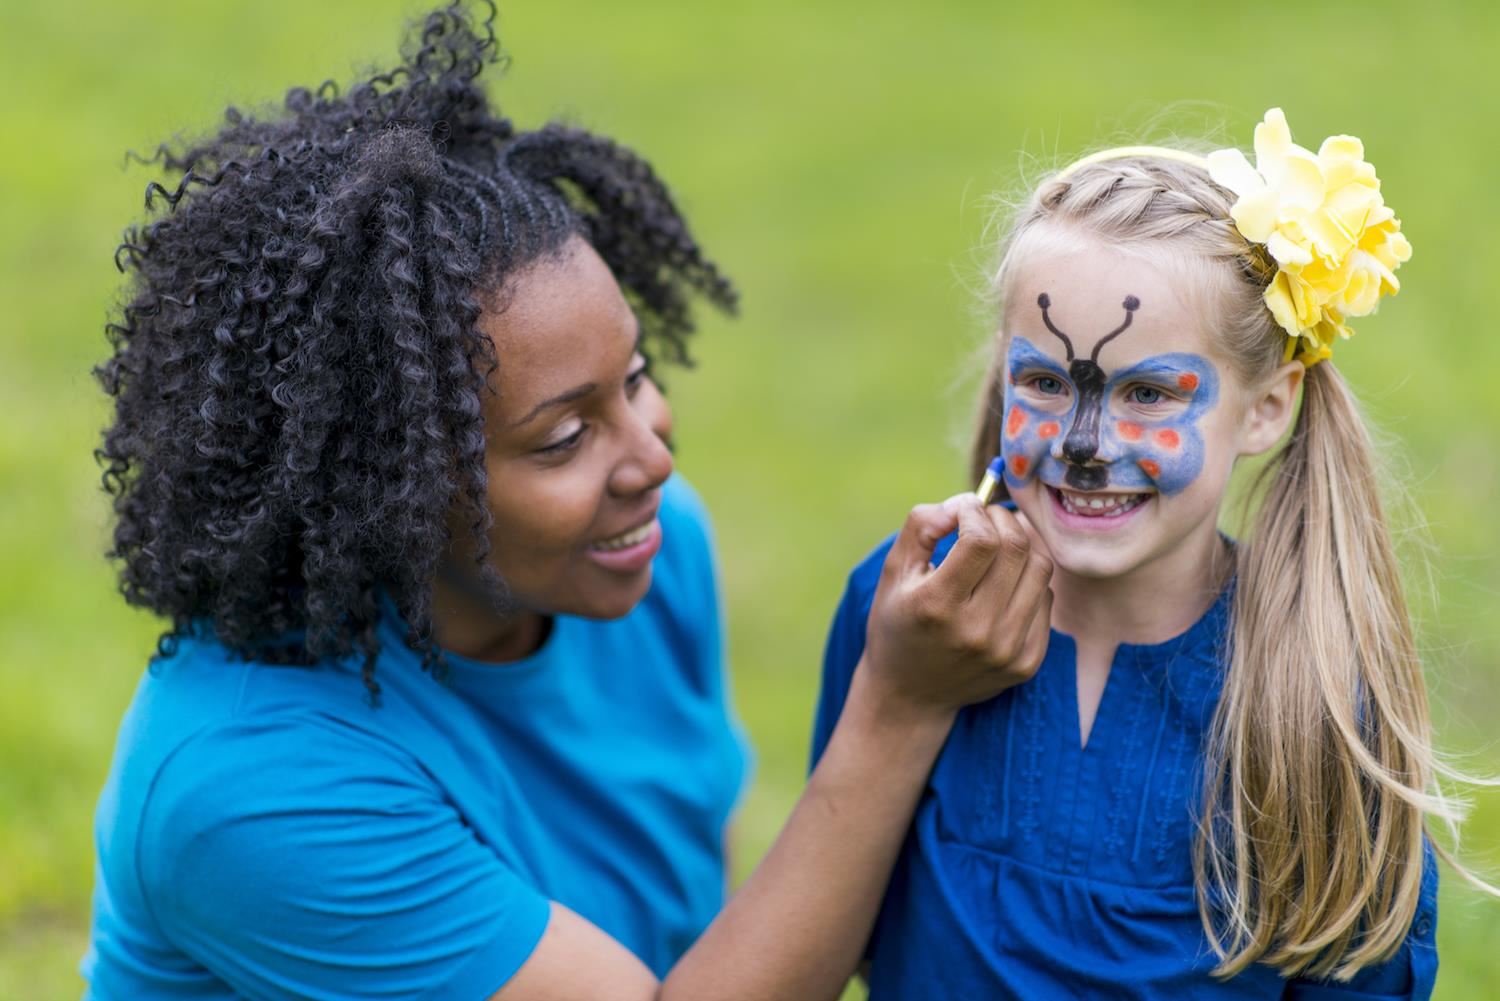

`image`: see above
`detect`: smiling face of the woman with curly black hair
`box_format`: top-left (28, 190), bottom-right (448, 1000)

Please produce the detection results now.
top-left (468, 239), bottom-right (672, 618)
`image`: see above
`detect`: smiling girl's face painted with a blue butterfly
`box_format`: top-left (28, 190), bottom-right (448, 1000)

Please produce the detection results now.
top-left (1001, 242), bottom-right (1275, 578)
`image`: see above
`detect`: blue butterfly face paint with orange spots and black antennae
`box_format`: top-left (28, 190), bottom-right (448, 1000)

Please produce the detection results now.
top-left (1001, 293), bottom-right (1218, 495)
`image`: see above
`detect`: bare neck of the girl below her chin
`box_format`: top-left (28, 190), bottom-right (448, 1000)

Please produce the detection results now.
top-left (1052, 522), bottom-right (1235, 650)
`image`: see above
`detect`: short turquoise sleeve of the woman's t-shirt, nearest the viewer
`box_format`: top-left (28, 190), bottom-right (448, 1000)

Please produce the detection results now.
top-left (138, 719), bottom-right (551, 1001)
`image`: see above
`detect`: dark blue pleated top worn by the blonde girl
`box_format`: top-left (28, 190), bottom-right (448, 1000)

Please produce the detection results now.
top-left (813, 536), bottom-right (1437, 1001)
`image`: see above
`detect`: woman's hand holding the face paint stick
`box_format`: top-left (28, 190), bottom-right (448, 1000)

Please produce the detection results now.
top-left (861, 494), bottom-right (1052, 719)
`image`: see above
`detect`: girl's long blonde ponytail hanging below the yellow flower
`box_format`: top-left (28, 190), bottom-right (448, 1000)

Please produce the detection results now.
top-left (1196, 362), bottom-right (1452, 977)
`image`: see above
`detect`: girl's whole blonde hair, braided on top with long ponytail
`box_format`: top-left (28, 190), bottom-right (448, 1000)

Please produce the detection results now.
top-left (972, 156), bottom-right (1476, 978)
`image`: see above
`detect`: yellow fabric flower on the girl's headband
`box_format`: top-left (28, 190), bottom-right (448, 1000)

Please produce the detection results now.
top-left (1208, 108), bottom-right (1412, 365)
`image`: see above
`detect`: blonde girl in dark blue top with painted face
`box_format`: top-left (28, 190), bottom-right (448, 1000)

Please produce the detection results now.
top-left (813, 110), bottom-right (1476, 999)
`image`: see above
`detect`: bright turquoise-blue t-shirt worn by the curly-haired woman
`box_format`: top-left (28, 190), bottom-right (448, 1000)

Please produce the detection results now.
top-left (84, 479), bottom-right (746, 1001)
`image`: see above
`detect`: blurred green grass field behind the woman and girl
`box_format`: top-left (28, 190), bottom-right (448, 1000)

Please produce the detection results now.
top-left (0, 0), bottom-right (1500, 999)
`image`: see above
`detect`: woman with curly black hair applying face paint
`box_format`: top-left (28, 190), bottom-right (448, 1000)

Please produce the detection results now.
top-left (86, 6), bottom-right (1050, 1001)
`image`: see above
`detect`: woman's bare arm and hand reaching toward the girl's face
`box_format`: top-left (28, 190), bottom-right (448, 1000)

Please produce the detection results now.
top-left (494, 497), bottom-right (1052, 1001)
